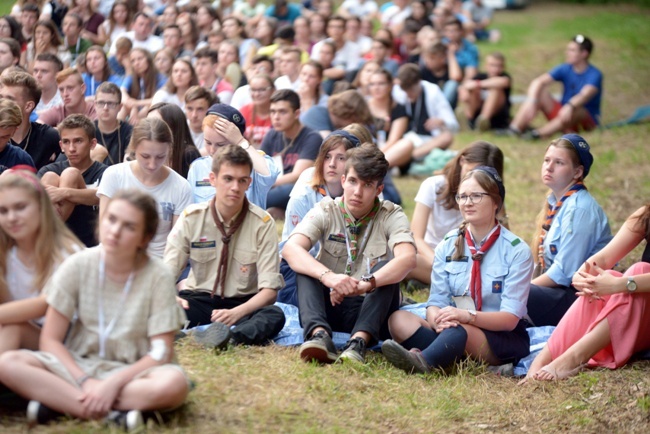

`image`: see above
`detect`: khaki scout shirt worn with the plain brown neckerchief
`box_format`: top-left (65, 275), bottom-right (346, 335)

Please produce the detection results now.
top-left (164, 202), bottom-right (284, 298)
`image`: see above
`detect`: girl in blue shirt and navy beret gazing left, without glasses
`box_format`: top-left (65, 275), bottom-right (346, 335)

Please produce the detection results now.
top-left (528, 134), bottom-right (612, 326)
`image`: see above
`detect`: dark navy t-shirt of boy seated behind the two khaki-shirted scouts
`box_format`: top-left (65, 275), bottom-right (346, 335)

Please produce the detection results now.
top-left (261, 126), bottom-right (323, 173)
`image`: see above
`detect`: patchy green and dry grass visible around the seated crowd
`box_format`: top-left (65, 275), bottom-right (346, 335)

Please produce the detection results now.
top-left (0, 2), bottom-right (650, 433)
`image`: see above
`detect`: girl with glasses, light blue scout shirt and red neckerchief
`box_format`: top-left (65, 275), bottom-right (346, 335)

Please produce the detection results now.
top-left (382, 166), bottom-right (533, 374)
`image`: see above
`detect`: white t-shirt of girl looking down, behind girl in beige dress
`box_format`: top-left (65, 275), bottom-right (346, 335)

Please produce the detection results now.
top-left (97, 161), bottom-right (192, 257)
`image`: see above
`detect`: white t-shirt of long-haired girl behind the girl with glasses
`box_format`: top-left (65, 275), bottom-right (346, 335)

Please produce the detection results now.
top-left (416, 175), bottom-right (463, 249)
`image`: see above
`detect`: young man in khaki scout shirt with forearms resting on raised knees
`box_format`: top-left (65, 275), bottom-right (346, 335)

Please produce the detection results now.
top-left (282, 143), bottom-right (415, 363)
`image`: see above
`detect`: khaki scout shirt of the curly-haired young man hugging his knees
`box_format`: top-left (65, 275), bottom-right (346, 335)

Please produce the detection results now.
top-left (291, 197), bottom-right (415, 278)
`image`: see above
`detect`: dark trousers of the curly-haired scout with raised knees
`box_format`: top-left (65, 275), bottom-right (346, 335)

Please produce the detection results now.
top-left (296, 274), bottom-right (400, 344)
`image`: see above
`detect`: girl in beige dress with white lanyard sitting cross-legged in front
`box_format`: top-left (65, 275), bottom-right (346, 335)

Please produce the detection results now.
top-left (0, 190), bottom-right (188, 429)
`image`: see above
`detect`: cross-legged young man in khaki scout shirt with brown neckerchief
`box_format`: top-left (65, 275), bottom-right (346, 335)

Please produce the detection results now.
top-left (164, 145), bottom-right (285, 348)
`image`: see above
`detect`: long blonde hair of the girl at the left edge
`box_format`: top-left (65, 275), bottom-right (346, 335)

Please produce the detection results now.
top-left (0, 170), bottom-right (82, 303)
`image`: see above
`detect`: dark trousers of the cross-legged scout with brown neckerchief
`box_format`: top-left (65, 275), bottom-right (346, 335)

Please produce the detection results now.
top-left (178, 291), bottom-right (285, 345)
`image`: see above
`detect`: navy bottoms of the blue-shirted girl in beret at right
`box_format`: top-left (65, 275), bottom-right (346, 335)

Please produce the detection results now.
top-left (527, 285), bottom-right (578, 327)
